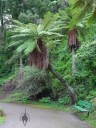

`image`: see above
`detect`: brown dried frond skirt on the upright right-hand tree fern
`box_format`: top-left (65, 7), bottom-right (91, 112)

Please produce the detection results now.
top-left (68, 29), bottom-right (80, 51)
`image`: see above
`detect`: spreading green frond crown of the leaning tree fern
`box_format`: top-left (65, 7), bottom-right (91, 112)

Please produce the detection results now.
top-left (9, 13), bottom-right (63, 54)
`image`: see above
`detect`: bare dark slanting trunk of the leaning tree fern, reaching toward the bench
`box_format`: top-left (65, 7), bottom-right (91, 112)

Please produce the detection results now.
top-left (49, 65), bottom-right (77, 104)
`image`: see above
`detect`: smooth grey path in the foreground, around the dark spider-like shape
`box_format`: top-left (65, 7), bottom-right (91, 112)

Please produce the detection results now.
top-left (0, 103), bottom-right (88, 128)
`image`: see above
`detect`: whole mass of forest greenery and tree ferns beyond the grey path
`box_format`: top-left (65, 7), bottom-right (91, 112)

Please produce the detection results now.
top-left (0, 0), bottom-right (96, 128)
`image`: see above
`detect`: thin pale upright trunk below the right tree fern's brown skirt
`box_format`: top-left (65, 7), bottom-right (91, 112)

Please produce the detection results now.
top-left (72, 48), bottom-right (76, 76)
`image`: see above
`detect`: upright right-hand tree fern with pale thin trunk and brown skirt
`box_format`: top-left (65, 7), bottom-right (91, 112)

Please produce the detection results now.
top-left (59, 7), bottom-right (84, 75)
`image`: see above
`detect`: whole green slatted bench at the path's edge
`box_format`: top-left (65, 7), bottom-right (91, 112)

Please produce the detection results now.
top-left (73, 100), bottom-right (92, 116)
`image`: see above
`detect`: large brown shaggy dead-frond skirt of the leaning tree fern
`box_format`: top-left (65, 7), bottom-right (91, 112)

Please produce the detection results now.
top-left (29, 39), bottom-right (49, 69)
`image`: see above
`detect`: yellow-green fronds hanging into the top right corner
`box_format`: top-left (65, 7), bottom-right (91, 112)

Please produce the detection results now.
top-left (70, 0), bottom-right (96, 25)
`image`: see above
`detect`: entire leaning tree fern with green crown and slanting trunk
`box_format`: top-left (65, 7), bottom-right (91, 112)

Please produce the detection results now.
top-left (10, 13), bottom-right (77, 103)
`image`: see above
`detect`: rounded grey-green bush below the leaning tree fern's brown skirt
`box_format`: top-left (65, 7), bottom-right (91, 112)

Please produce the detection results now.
top-left (19, 66), bottom-right (51, 97)
